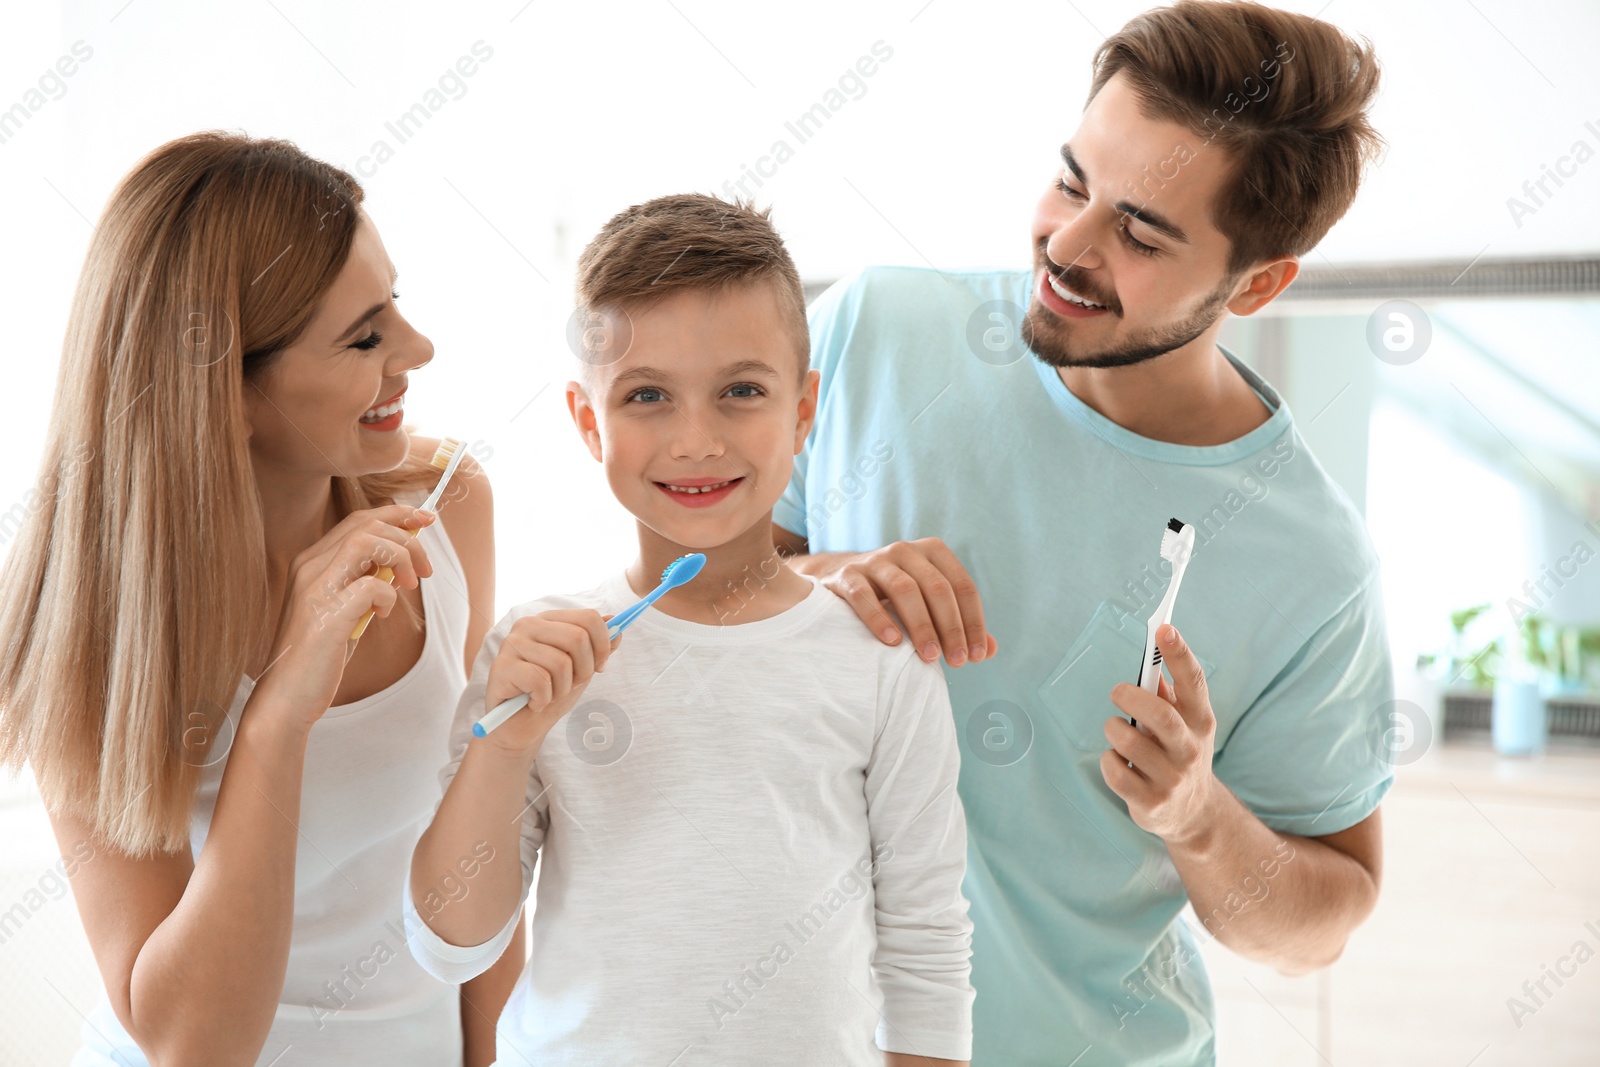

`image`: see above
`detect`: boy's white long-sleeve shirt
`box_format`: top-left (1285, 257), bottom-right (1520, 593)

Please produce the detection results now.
top-left (405, 574), bottom-right (973, 1067)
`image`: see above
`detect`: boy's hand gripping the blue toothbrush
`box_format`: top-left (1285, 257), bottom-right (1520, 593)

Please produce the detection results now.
top-left (483, 608), bottom-right (622, 758)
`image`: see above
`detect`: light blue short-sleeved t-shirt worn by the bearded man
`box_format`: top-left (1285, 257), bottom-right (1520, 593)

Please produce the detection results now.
top-left (773, 267), bottom-right (1392, 1067)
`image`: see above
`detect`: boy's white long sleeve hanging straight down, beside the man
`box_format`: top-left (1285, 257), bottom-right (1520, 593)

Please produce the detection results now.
top-left (866, 654), bottom-right (973, 1059)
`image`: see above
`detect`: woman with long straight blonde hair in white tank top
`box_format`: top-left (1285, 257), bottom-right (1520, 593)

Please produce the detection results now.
top-left (0, 133), bottom-right (522, 1067)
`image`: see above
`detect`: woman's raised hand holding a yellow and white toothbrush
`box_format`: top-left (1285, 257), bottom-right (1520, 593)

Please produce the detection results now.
top-left (258, 504), bottom-right (435, 728)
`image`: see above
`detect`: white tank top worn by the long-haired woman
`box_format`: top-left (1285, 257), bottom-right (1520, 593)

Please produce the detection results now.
top-left (72, 493), bottom-right (469, 1067)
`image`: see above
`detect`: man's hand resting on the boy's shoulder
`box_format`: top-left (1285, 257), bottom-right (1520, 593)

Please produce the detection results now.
top-left (773, 525), bottom-right (998, 667)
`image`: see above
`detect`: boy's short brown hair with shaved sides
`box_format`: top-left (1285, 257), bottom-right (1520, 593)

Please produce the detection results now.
top-left (576, 194), bottom-right (811, 379)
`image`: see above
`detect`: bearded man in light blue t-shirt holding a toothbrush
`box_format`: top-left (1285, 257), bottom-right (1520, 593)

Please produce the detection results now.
top-left (774, 2), bottom-right (1392, 1067)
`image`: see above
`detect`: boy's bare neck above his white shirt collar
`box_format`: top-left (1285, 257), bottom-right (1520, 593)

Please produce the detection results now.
top-left (627, 514), bottom-right (811, 625)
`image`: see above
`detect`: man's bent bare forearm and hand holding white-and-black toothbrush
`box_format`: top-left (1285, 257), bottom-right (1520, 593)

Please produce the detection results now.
top-left (1101, 625), bottom-right (1382, 974)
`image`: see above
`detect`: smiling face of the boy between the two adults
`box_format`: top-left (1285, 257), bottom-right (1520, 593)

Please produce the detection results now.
top-left (566, 283), bottom-right (819, 620)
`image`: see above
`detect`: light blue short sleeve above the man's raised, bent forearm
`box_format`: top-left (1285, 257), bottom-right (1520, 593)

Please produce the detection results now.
top-left (1213, 571), bottom-right (1394, 837)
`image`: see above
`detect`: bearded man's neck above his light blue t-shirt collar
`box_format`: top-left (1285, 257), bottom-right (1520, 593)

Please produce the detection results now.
top-left (1056, 330), bottom-right (1272, 446)
